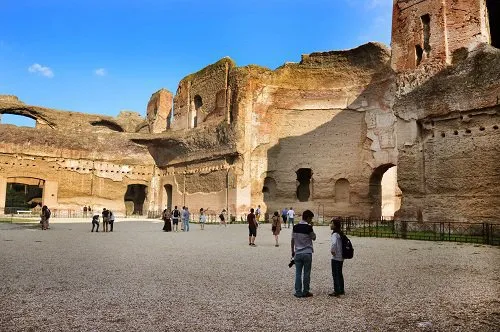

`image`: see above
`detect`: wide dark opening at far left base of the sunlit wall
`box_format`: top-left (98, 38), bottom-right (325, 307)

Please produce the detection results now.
top-left (5, 177), bottom-right (45, 213)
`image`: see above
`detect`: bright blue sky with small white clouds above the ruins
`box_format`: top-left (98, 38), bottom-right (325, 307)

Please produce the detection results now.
top-left (0, 0), bottom-right (393, 123)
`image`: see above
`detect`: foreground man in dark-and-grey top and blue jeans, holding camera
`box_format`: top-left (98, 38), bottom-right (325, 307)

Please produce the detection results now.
top-left (290, 208), bottom-right (316, 297)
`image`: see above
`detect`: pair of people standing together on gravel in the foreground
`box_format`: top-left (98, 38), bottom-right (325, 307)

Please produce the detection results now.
top-left (291, 210), bottom-right (344, 297)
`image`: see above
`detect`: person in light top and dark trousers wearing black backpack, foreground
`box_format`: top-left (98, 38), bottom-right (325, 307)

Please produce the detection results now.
top-left (328, 220), bottom-right (345, 297)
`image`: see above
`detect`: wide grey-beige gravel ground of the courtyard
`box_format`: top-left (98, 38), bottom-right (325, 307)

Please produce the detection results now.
top-left (0, 220), bottom-right (500, 331)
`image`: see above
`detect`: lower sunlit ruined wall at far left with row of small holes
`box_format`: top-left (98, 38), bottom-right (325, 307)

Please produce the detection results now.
top-left (0, 102), bottom-right (156, 214)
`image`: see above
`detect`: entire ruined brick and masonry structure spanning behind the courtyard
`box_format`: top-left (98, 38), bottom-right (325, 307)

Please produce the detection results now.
top-left (0, 0), bottom-right (500, 221)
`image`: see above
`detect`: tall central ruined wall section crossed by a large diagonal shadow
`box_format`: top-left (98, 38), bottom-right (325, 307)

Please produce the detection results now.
top-left (230, 44), bottom-right (397, 216)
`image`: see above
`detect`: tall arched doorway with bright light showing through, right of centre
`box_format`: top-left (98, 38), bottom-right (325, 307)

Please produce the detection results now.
top-left (369, 164), bottom-right (401, 220)
